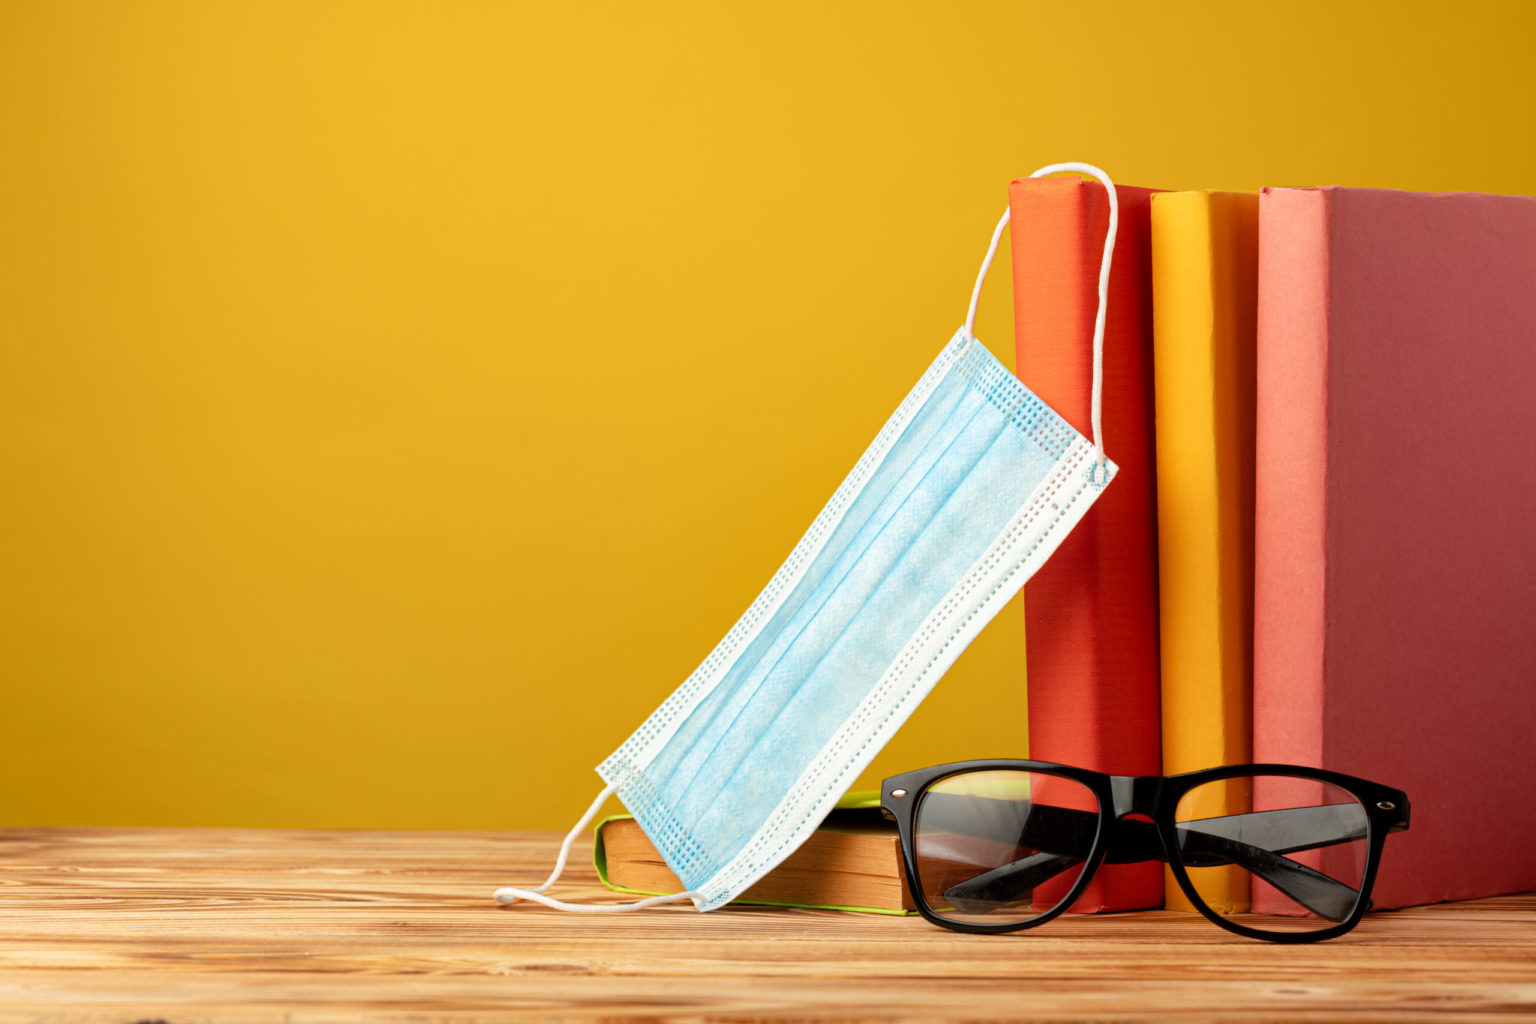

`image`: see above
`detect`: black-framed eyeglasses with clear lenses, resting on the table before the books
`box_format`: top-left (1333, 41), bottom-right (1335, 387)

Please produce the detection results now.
top-left (880, 760), bottom-right (1409, 943)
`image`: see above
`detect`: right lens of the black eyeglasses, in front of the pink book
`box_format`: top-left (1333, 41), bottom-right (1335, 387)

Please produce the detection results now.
top-left (1174, 775), bottom-right (1369, 932)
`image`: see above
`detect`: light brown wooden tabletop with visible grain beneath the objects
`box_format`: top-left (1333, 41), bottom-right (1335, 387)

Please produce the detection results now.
top-left (0, 829), bottom-right (1536, 1024)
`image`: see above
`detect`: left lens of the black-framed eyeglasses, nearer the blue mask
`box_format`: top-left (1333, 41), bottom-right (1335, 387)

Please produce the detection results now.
top-left (912, 771), bottom-right (1098, 924)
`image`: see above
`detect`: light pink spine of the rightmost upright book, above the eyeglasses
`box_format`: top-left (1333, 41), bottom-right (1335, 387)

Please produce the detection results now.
top-left (1253, 189), bottom-right (1330, 768)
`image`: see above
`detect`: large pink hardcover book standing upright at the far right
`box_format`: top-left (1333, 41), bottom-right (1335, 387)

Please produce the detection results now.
top-left (1253, 187), bottom-right (1536, 907)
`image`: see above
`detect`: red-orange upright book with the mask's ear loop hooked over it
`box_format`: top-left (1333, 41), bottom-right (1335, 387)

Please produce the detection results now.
top-left (1008, 178), bottom-right (1163, 912)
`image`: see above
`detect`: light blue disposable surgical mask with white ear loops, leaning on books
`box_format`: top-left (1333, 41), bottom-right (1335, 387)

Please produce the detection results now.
top-left (495, 164), bottom-right (1118, 910)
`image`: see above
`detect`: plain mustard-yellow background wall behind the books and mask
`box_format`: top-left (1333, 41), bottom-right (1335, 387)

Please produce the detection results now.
top-left (0, 0), bottom-right (1536, 827)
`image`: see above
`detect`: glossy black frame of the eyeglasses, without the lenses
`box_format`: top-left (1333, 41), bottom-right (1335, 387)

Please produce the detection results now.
top-left (880, 758), bottom-right (1409, 943)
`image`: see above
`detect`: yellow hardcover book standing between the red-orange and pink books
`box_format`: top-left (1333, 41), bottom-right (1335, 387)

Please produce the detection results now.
top-left (1152, 192), bottom-right (1258, 910)
